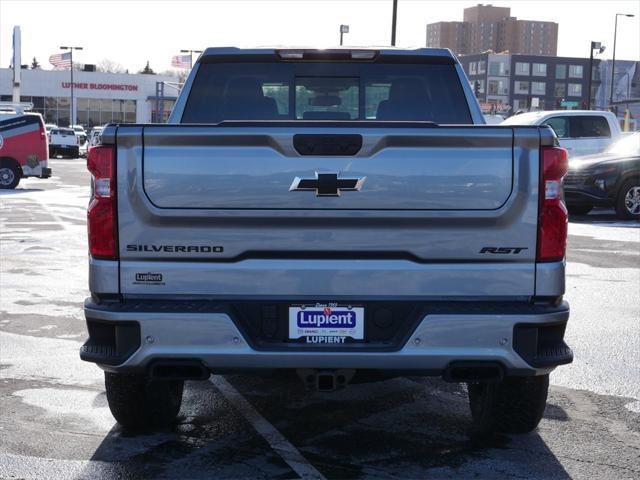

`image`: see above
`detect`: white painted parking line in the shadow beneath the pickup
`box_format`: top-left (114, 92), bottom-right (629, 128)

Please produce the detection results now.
top-left (210, 375), bottom-right (326, 480)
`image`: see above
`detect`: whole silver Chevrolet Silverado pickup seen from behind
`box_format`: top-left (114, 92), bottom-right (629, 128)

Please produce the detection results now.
top-left (81, 48), bottom-right (572, 432)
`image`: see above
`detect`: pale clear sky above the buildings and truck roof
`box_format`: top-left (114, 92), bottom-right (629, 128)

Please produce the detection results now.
top-left (0, 0), bottom-right (640, 72)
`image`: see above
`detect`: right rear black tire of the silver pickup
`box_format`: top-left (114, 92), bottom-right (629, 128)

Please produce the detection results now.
top-left (468, 375), bottom-right (549, 435)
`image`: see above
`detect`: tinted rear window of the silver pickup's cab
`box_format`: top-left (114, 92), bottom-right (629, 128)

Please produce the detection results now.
top-left (182, 62), bottom-right (472, 124)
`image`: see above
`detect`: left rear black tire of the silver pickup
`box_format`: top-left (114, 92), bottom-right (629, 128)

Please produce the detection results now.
top-left (104, 372), bottom-right (184, 430)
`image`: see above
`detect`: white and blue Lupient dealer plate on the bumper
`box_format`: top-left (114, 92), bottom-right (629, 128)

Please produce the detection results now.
top-left (289, 304), bottom-right (364, 344)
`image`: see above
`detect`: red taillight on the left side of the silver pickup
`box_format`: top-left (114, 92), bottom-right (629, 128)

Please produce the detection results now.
top-left (87, 145), bottom-right (118, 260)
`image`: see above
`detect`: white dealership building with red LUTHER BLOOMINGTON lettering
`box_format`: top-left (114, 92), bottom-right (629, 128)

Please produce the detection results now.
top-left (0, 68), bottom-right (178, 127)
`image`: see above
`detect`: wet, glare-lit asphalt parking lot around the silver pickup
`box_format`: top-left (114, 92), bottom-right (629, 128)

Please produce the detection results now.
top-left (0, 159), bottom-right (640, 479)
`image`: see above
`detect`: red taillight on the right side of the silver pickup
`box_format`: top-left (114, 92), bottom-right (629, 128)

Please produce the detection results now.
top-left (537, 147), bottom-right (569, 262)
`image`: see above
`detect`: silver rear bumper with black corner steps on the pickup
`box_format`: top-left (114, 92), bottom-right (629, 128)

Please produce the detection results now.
top-left (80, 299), bottom-right (573, 376)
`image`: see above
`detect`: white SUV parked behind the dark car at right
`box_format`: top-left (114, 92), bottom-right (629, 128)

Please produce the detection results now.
top-left (502, 110), bottom-right (621, 157)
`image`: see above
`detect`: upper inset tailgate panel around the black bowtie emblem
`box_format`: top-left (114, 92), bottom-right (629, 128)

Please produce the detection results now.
top-left (143, 126), bottom-right (513, 210)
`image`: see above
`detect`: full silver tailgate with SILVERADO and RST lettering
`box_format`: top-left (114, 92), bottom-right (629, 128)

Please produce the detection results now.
top-left (114, 124), bottom-right (540, 299)
